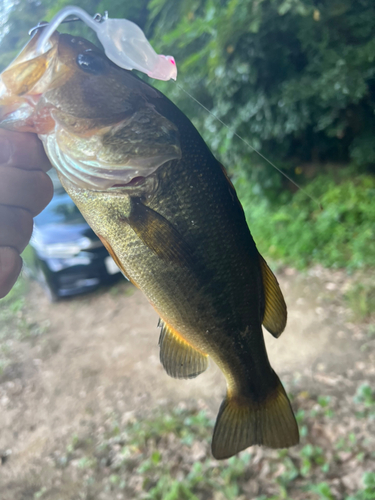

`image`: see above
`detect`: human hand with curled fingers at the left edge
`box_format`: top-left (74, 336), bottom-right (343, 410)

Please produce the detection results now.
top-left (0, 129), bottom-right (53, 298)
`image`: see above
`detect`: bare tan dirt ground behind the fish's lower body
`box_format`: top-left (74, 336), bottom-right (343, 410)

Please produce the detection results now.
top-left (0, 268), bottom-right (374, 500)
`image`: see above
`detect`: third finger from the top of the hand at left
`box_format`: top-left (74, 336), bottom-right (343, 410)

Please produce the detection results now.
top-left (0, 205), bottom-right (33, 254)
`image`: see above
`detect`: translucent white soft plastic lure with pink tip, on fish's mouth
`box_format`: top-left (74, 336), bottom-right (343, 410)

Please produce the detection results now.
top-left (36, 6), bottom-right (177, 80)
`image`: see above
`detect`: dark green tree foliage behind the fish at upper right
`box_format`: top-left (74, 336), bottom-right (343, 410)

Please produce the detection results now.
top-left (149, 0), bottom-right (375, 188)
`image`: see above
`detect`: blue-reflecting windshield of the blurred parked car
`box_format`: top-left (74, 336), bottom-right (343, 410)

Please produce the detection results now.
top-left (35, 170), bottom-right (85, 226)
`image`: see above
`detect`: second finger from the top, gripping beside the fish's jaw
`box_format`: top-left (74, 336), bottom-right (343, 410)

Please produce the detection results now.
top-left (0, 165), bottom-right (53, 217)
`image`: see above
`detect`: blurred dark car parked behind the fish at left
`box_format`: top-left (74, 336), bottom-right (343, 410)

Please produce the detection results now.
top-left (24, 172), bottom-right (120, 301)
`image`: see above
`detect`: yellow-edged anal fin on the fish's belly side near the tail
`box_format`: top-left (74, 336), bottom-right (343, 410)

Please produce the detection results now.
top-left (159, 320), bottom-right (208, 378)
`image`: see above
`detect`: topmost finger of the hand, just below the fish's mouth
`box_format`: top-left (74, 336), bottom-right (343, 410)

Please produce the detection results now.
top-left (0, 129), bottom-right (51, 172)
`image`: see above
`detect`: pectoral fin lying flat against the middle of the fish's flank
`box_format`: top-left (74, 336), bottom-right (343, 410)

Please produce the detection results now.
top-left (126, 199), bottom-right (194, 266)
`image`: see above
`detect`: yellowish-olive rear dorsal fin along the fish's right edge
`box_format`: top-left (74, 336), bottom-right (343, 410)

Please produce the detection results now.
top-left (259, 255), bottom-right (287, 338)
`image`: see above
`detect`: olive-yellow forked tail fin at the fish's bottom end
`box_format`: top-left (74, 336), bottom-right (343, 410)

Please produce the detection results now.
top-left (212, 374), bottom-right (299, 459)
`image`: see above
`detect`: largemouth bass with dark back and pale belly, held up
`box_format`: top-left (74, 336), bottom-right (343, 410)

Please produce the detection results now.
top-left (0, 28), bottom-right (299, 459)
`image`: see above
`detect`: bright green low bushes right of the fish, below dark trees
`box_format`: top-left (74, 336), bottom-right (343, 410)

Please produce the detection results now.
top-left (235, 170), bottom-right (375, 269)
